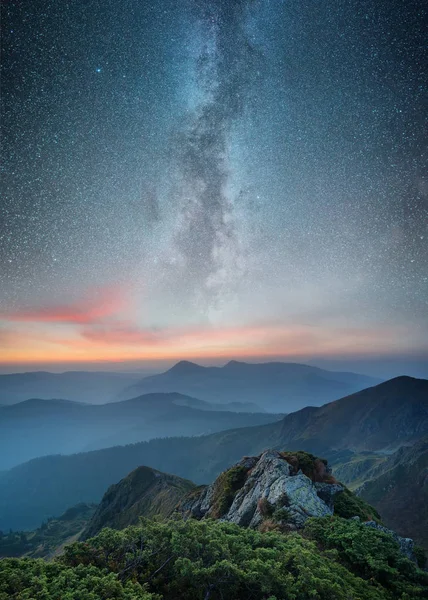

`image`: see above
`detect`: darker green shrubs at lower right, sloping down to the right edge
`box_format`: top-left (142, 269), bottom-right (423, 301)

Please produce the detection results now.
top-left (305, 517), bottom-right (428, 599)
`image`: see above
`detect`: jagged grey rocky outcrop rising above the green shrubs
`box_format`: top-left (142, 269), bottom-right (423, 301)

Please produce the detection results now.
top-left (180, 450), bottom-right (343, 528)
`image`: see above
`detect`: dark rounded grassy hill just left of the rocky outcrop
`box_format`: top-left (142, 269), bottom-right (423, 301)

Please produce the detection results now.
top-left (82, 467), bottom-right (195, 539)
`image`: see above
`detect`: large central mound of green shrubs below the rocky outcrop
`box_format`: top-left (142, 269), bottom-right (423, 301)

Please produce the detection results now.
top-left (61, 519), bottom-right (394, 600)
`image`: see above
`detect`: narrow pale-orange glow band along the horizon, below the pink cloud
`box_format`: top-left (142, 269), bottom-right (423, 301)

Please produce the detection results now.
top-left (0, 318), bottom-right (418, 364)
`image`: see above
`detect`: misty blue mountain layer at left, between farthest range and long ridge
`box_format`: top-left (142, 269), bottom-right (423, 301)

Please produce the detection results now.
top-left (0, 393), bottom-right (280, 470)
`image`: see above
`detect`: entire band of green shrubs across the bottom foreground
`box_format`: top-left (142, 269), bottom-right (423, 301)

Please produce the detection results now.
top-left (0, 517), bottom-right (428, 600)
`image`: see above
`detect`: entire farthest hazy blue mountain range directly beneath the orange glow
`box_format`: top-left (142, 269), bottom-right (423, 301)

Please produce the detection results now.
top-left (0, 361), bottom-right (380, 413)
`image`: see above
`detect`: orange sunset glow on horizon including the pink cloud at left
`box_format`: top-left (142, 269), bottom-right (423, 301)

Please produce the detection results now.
top-left (0, 287), bottom-right (422, 365)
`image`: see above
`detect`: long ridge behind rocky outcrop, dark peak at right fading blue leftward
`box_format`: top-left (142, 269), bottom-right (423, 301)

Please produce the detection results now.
top-left (0, 377), bottom-right (428, 540)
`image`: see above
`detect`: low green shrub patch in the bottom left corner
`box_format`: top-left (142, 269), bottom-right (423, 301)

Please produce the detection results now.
top-left (0, 558), bottom-right (156, 600)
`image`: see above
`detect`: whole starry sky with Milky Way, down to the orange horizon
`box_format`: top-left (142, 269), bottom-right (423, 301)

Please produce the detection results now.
top-left (0, 0), bottom-right (428, 375)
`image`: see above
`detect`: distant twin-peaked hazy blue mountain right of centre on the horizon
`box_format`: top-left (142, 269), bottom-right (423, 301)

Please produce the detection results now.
top-left (121, 361), bottom-right (379, 413)
